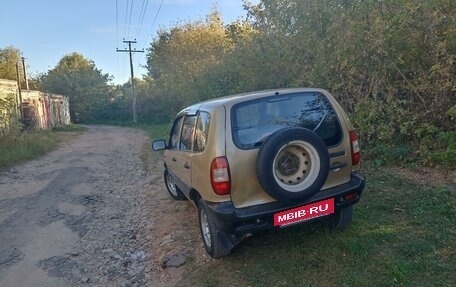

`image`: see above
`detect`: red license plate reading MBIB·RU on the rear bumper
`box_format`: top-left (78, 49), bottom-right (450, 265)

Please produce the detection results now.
top-left (274, 198), bottom-right (334, 226)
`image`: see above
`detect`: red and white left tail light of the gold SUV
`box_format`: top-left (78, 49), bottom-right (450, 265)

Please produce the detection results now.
top-left (211, 156), bottom-right (231, 195)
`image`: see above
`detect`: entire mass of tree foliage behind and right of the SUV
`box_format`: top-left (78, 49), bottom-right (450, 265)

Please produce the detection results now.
top-left (139, 0), bottom-right (456, 166)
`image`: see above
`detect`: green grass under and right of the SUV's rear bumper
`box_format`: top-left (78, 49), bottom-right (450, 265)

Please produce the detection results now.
top-left (176, 167), bottom-right (456, 286)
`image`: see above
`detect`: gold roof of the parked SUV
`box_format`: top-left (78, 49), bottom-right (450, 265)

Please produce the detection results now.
top-left (178, 88), bottom-right (328, 115)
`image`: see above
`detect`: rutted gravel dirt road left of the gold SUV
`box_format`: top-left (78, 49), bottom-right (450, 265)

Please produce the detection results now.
top-left (0, 126), bottom-right (209, 287)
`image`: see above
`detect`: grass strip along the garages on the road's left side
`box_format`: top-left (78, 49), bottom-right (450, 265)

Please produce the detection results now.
top-left (0, 125), bottom-right (85, 169)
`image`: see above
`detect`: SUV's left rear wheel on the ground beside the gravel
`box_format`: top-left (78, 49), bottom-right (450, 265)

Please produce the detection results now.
top-left (198, 199), bottom-right (231, 258)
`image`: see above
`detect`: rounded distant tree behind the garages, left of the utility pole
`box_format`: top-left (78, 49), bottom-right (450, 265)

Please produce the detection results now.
top-left (40, 53), bottom-right (112, 121)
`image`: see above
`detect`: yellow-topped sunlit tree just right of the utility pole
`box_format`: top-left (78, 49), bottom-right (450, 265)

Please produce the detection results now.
top-left (147, 11), bottom-right (233, 118)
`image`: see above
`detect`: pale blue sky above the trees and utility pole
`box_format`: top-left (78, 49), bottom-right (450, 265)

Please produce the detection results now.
top-left (0, 0), bottom-right (259, 84)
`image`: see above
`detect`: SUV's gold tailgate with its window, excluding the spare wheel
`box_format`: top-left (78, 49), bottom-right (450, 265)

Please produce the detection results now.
top-left (226, 91), bottom-right (351, 208)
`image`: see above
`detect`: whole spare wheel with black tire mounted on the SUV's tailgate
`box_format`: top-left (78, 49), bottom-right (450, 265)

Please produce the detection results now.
top-left (257, 128), bottom-right (329, 201)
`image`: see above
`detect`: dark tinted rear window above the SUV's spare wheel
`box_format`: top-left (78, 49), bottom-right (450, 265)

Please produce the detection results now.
top-left (231, 92), bottom-right (342, 149)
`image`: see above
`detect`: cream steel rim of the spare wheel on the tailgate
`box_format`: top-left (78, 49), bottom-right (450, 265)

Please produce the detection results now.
top-left (272, 141), bottom-right (320, 192)
